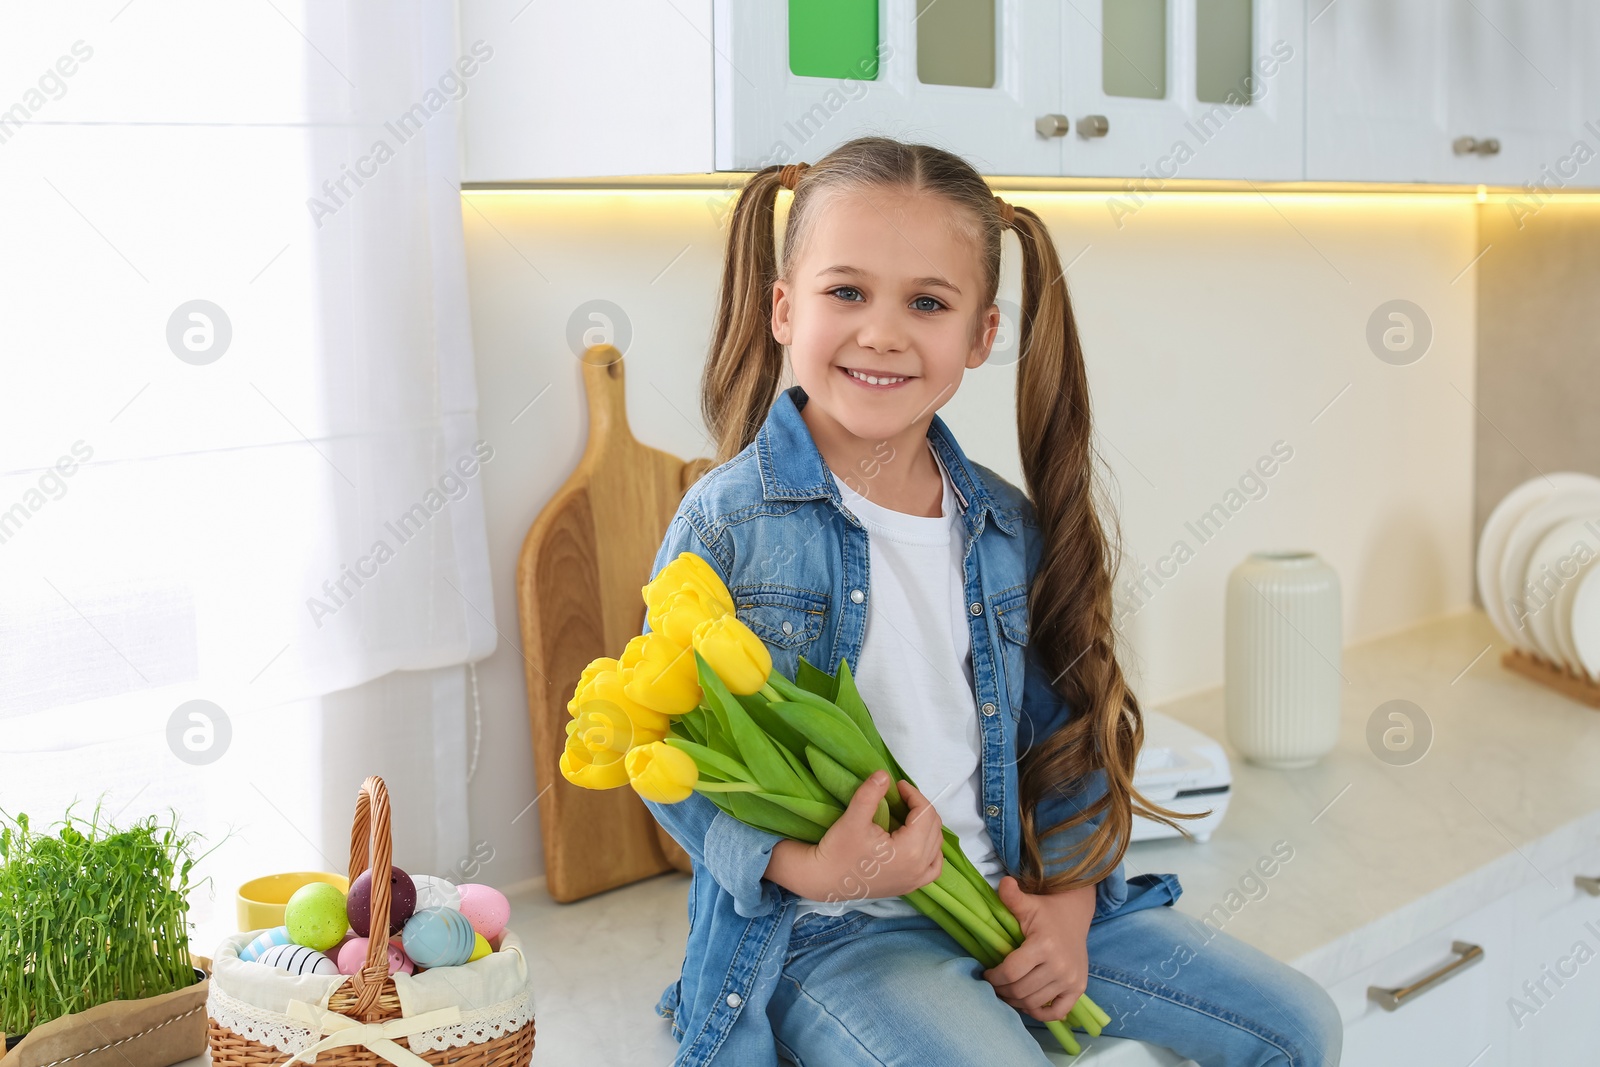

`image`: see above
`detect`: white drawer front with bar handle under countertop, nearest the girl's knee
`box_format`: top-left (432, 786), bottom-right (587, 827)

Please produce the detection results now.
top-left (1328, 893), bottom-right (1522, 1067)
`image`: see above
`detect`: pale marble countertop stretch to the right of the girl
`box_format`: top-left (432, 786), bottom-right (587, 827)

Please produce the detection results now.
top-left (1125, 609), bottom-right (1600, 987)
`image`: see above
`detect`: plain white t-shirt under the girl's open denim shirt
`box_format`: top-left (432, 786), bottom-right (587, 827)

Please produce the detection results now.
top-left (795, 442), bottom-right (1002, 920)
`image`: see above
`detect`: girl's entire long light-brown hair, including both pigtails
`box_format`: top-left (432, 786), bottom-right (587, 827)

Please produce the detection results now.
top-left (701, 138), bottom-right (1202, 893)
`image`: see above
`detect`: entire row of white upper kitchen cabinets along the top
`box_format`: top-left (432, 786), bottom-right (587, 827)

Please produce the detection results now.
top-left (461, 0), bottom-right (1600, 189)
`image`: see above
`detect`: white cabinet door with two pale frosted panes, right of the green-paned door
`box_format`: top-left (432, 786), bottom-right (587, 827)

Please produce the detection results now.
top-left (1061, 0), bottom-right (1306, 187)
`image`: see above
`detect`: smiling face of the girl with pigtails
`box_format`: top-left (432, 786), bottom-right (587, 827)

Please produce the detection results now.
top-left (773, 187), bottom-right (1000, 442)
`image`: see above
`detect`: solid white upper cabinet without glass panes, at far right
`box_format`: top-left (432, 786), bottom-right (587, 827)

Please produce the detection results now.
top-left (1306, 0), bottom-right (1600, 186)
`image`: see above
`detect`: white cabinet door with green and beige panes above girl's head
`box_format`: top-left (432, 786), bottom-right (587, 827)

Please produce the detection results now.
top-left (712, 0), bottom-right (1062, 176)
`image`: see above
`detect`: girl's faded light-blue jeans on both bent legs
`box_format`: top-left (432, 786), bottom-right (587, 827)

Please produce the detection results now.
top-left (768, 905), bottom-right (1344, 1067)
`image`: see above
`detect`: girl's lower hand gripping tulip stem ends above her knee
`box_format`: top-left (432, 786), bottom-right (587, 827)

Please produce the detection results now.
top-left (984, 875), bottom-right (1094, 1022)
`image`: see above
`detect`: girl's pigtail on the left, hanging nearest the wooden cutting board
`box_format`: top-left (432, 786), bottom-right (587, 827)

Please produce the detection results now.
top-left (701, 166), bottom-right (784, 469)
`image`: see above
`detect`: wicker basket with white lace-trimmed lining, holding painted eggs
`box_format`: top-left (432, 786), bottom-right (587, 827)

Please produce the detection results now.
top-left (206, 774), bottom-right (534, 1067)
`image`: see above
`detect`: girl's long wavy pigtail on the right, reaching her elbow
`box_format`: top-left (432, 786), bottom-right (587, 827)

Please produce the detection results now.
top-left (1011, 206), bottom-right (1202, 893)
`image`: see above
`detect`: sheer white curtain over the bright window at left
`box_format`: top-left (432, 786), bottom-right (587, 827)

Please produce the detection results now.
top-left (0, 0), bottom-right (496, 952)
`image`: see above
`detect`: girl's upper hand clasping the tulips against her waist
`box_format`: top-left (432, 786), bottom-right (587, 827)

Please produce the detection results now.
top-left (813, 771), bottom-right (944, 901)
